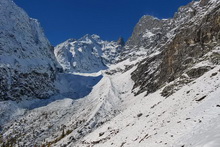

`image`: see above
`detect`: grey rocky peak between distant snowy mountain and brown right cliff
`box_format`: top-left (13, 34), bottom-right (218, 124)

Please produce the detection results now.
top-left (120, 15), bottom-right (174, 60)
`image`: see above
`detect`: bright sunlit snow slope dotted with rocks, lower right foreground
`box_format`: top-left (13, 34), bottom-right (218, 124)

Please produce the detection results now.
top-left (74, 54), bottom-right (220, 147)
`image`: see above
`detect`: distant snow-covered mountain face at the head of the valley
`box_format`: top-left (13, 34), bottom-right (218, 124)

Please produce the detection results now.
top-left (54, 35), bottom-right (124, 73)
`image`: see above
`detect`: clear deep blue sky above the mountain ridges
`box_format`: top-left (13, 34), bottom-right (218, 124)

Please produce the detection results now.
top-left (14, 0), bottom-right (192, 45)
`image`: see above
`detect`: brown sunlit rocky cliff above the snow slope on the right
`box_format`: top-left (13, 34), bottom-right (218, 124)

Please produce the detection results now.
top-left (132, 1), bottom-right (220, 94)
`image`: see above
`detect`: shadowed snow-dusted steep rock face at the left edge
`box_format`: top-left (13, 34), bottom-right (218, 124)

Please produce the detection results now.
top-left (0, 0), bottom-right (57, 100)
